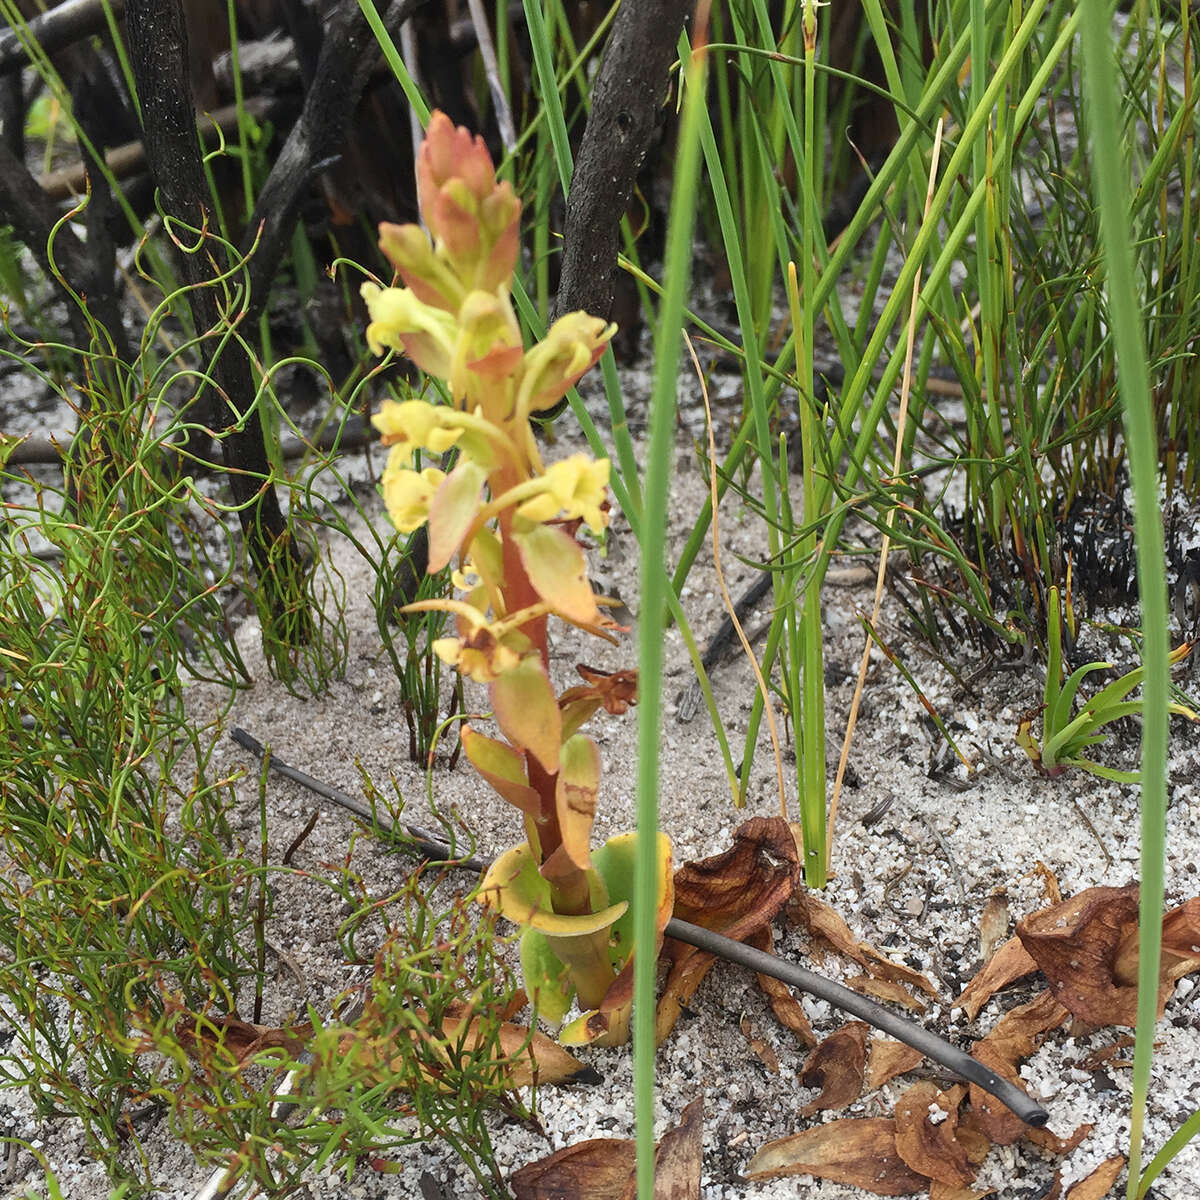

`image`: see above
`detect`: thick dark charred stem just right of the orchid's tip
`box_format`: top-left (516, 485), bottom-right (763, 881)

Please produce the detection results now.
top-left (554, 0), bottom-right (695, 320)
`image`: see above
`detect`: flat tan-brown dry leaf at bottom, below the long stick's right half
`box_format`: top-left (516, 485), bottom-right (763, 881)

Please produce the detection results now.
top-left (745, 1117), bottom-right (929, 1196)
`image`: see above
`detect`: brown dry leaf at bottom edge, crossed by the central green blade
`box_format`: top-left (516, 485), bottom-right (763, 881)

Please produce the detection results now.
top-left (509, 1100), bottom-right (703, 1200)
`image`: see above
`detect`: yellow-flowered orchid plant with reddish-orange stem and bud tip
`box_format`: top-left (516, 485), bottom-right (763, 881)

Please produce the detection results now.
top-left (362, 113), bottom-right (672, 1044)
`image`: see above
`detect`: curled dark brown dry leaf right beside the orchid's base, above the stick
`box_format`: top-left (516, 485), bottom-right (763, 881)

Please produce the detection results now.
top-left (655, 817), bottom-right (800, 1042)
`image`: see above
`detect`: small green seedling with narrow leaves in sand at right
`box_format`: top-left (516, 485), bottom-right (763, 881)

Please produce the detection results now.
top-left (1016, 588), bottom-right (1200, 784)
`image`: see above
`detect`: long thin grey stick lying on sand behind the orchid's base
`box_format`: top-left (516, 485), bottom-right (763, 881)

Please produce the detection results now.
top-left (230, 727), bottom-right (1050, 1129)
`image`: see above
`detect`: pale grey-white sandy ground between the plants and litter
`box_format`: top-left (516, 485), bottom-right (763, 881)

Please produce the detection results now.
top-left (0, 388), bottom-right (1200, 1200)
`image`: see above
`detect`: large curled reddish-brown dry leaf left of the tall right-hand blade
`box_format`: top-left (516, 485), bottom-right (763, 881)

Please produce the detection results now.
top-left (1016, 884), bottom-right (1142, 1025)
